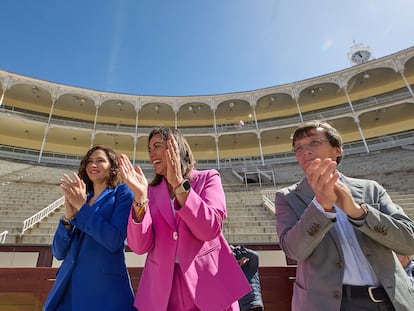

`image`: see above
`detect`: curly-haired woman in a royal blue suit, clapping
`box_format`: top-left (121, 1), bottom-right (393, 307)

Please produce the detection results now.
top-left (43, 146), bottom-right (135, 311)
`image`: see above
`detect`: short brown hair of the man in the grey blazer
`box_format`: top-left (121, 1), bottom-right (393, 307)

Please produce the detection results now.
top-left (292, 120), bottom-right (343, 165)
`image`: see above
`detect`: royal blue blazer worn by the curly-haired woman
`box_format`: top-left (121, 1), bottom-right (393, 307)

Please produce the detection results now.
top-left (43, 184), bottom-right (135, 311)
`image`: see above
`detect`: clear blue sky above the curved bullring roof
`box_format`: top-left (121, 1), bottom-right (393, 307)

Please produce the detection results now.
top-left (0, 0), bottom-right (414, 96)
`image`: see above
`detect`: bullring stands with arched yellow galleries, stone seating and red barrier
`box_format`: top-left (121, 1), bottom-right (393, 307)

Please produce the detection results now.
top-left (0, 48), bottom-right (414, 311)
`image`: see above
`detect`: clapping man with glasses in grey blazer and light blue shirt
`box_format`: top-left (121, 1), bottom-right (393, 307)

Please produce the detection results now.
top-left (275, 121), bottom-right (414, 311)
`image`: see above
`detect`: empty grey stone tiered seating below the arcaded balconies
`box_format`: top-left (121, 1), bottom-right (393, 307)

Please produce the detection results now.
top-left (0, 148), bottom-right (414, 244)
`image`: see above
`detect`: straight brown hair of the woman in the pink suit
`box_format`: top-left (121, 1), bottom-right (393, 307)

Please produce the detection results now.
top-left (148, 127), bottom-right (196, 186)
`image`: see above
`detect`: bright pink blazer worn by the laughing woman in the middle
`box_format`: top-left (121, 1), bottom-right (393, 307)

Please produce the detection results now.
top-left (127, 170), bottom-right (251, 311)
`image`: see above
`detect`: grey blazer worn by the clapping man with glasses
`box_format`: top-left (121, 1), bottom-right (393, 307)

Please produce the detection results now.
top-left (275, 176), bottom-right (414, 311)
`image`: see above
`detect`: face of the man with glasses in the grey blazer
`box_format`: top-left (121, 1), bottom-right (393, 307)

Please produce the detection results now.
top-left (293, 128), bottom-right (342, 172)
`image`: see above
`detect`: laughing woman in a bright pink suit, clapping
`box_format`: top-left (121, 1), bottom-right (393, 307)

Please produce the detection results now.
top-left (120, 128), bottom-right (251, 311)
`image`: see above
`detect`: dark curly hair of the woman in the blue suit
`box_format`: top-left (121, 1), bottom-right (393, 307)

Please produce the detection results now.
top-left (78, 145), bottom-right (122, 193)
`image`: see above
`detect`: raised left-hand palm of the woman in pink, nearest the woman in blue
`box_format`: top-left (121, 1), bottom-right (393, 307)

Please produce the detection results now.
top-left (119, 154), bottom-right (148, 202)
